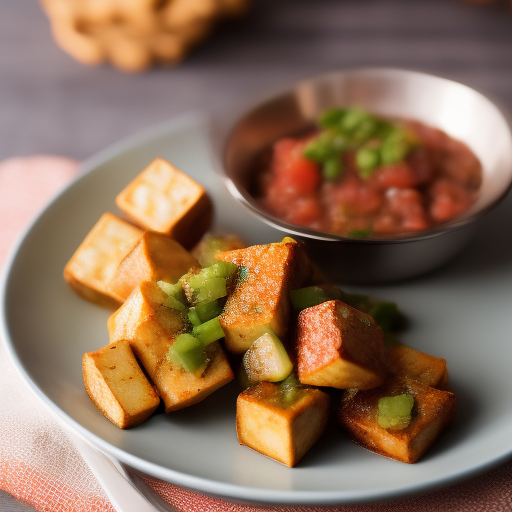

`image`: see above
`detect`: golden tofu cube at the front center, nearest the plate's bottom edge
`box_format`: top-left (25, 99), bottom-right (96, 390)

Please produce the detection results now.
top-left (236, 382), bottom-right (330, 467)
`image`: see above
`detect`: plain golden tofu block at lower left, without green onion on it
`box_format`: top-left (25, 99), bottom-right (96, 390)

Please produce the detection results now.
top-left (82, 340), bottom-right (160, 428)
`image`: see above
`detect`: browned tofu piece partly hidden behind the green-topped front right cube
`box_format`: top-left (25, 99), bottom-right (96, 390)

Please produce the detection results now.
top-left (386, 345), bottom-right (448, 389)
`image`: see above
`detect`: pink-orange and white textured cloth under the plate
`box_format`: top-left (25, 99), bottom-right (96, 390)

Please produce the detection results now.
top-left (0, 157), bottom-right (512, 512)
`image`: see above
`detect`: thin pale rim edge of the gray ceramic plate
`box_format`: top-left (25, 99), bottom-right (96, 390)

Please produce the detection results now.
top-left (4, 112), bottom-right (512, 505)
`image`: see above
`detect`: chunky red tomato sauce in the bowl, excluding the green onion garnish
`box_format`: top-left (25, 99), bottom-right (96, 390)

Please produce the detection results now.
top-left (256, 111), bottom-right (481, 237)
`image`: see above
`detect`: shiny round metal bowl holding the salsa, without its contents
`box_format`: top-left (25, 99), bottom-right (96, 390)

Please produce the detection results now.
top-left (221, 68), bottom-right (512, 283)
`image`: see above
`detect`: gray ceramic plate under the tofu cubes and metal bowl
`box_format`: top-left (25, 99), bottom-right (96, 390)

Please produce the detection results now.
top-left (2, 116), bottom-right (512, 504)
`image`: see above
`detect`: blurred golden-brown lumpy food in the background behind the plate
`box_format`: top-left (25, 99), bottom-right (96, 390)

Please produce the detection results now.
top-left (41, 0), bottom-right (250, 72)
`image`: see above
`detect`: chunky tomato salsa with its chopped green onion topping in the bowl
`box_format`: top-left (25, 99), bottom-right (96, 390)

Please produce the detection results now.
top-left (256, 108), bottom-right (482, 237)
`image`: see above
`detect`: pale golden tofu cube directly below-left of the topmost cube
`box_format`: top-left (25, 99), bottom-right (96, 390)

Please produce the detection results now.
top-left (64, 213), bottom-right (143, 307)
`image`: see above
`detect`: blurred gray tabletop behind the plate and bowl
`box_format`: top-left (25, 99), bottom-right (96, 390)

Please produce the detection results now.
top-left (0, 0), bottom-right (512, 509)
